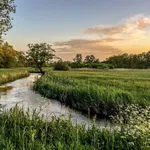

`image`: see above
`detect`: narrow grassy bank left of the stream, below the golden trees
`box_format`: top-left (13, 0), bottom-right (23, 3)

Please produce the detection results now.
top-left (0, 68), bottom-right (29, 85)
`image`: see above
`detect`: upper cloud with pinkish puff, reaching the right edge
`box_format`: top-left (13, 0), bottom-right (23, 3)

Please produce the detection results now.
top-left (84, 14), bottom-right (150, 36)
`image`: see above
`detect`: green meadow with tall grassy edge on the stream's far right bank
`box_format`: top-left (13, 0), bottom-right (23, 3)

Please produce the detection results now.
top-left (35, 70), bottom-right (150, 117)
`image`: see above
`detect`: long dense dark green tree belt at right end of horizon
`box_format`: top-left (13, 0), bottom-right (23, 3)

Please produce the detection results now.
top-left (105, 51), bottom-right (150, 69)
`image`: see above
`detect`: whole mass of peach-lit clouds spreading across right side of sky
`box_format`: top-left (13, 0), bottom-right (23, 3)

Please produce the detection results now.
top-left (54, 14), bottom-right (150, 60)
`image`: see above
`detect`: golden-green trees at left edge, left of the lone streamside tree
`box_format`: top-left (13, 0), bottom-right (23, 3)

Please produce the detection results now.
top-left (0, 42), bottom-right (26, 68)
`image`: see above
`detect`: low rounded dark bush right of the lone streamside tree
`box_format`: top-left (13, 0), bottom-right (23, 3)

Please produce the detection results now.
top-left (54, 61), bottom-right (70, 71)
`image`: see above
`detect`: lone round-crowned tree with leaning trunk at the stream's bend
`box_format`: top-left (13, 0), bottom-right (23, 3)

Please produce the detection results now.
top-left (27, 43), bottom-right (55, 74)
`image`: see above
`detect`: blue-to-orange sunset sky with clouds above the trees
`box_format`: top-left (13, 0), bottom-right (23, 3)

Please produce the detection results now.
top-left (4, 0), bottom-right (150, 60)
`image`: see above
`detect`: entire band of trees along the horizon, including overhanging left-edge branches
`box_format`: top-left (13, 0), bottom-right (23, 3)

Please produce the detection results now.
top-left (0, 0), bottom-right (150, 72)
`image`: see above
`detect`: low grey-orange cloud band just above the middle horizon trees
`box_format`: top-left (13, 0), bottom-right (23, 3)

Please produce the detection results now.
top-left (54, 38), bottom-right (122, 60)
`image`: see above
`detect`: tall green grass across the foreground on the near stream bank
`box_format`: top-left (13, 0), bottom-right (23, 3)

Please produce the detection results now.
top-left (0, 106), bottom-right (150, 150)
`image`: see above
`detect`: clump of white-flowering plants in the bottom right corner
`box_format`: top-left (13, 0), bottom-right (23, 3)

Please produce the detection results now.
top-left (112, 105), bottom-right (150, 150)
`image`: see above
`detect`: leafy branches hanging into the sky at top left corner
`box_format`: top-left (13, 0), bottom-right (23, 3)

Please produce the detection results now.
top-left (0, 0), bottom-right (16, 41)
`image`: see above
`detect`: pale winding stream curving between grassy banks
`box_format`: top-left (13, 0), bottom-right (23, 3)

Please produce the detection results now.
top-left (0, 73), bottom-right (109, 128)
